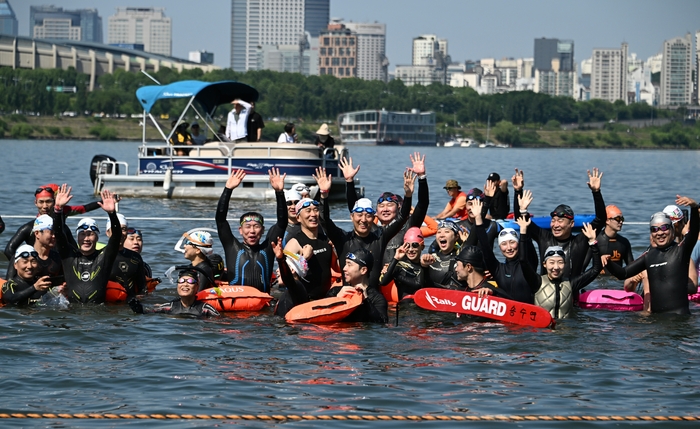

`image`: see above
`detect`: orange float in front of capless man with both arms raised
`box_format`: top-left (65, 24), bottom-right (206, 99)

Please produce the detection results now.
top-left (197, 282), bottom-right (273, 312)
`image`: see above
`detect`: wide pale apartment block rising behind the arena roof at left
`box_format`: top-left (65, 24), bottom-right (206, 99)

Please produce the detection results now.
top-left (107, 7), bottom-right (173, 57)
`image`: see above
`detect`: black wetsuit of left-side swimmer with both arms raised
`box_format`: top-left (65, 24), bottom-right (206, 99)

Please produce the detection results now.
top-left (53, 212), bottom-right (122, 304)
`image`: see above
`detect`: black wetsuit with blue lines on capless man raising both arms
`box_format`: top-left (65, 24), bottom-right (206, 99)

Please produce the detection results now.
top-left (216, 187), bottom-right (287, 293)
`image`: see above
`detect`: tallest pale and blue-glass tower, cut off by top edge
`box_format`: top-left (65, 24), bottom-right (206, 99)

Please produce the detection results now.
top-left (231, 0), bottom-right (330, 71)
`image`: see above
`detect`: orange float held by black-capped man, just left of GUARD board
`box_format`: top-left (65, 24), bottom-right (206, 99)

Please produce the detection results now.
top-left (285, 292), bottom-right (363, 323)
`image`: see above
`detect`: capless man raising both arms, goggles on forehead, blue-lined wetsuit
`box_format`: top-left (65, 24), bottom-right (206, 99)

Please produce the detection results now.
top-left (216, 168), bottom-right (287, 293)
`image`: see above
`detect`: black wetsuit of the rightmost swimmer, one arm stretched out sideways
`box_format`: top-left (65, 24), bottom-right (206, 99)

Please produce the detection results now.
top-left (607, 207), bottom-right (700, 314)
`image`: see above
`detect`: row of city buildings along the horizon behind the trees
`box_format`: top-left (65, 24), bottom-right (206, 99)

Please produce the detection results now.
top-left (0, 0), bottom-right (700, 106)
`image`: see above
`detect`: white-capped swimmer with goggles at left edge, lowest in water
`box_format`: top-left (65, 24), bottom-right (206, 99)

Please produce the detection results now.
top-left (2, 244), bottom-right (58, 306)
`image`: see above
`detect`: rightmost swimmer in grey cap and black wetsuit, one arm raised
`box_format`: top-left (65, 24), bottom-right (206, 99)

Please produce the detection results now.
top-left (607, 195), bottom-right (700, 314)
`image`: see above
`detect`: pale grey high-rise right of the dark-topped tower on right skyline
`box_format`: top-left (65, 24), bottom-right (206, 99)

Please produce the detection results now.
top-left (590, 43), bottom-right (628, 103)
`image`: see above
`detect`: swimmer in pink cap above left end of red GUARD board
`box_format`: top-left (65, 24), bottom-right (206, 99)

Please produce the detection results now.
top-left (379, 226), bottom-right (430, 301)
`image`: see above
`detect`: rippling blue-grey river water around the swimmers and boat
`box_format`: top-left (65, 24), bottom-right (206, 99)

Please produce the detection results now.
top-left (0, 140), bottom-right (700, 427)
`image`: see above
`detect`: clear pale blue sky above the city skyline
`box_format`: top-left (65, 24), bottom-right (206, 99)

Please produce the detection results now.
top-left (9, 0), bottom-right (700, 71)
